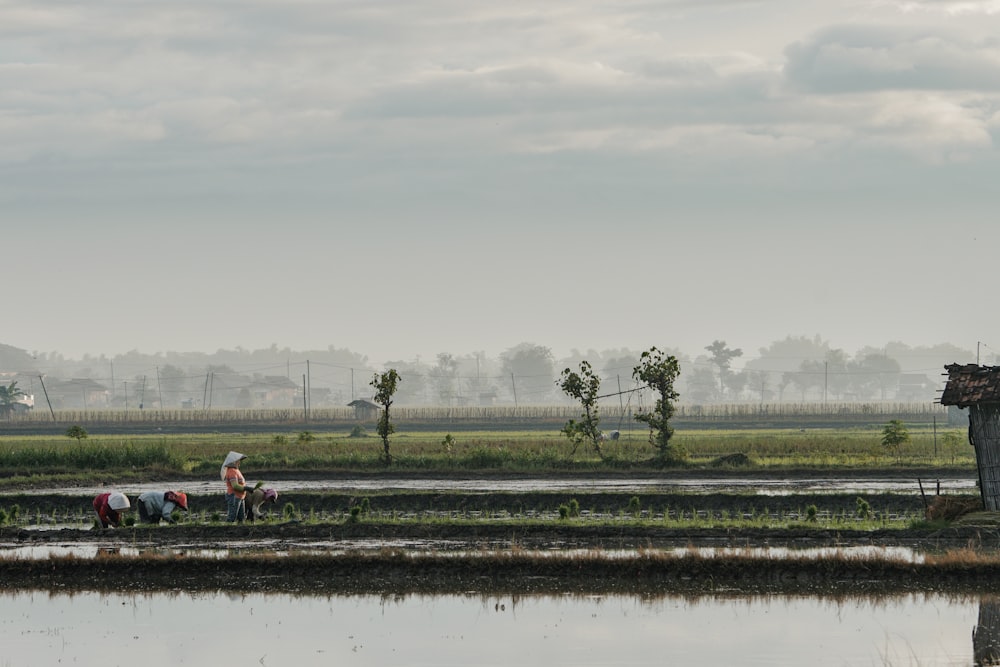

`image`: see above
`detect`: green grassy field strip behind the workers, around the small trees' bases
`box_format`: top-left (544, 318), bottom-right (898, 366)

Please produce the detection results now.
top-left (0, 428), bottom-right (975, 488)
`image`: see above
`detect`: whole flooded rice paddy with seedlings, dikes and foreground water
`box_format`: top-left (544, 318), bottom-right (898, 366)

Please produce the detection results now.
top-left (0, 476), bottom-right (1000, 667)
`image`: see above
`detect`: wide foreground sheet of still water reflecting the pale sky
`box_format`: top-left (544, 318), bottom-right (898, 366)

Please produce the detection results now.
top-left (0, 592), bottom-right (998, 667)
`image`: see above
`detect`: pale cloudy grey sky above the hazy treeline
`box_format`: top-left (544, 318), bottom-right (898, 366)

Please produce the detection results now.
top-left (0, 0), bottom-right (1000, 363)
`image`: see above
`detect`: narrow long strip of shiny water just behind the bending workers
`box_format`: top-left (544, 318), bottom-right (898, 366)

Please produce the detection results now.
top-left (9, 473), bottom-right (976, 495)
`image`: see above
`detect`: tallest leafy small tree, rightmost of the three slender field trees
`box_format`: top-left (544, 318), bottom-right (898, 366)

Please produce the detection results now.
top-left (632, 347), bottom-right (687, 465)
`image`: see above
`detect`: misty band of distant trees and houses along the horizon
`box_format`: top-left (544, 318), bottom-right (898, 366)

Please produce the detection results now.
top-left (0, 335), bottom-right (984, 409)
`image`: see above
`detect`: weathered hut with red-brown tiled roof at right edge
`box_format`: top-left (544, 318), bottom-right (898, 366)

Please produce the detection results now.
top-left (940, 364), bottom-right (1000, 511)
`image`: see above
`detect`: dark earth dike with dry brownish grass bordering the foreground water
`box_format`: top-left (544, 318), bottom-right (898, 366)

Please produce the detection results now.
top-left (0, 549), bottom-right (1000, 595)
